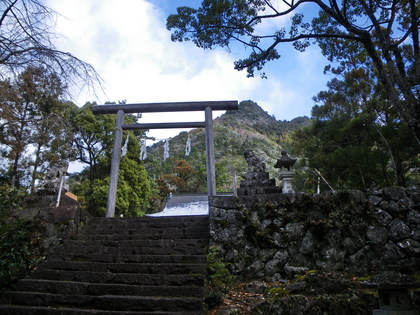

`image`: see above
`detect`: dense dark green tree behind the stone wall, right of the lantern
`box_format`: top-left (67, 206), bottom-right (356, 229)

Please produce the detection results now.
top-left (293, 67), bottom-right (418, 189)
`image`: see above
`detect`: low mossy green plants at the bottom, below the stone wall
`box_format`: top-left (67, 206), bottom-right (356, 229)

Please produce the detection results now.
top-left (253, 270), bottom-right (378, 314)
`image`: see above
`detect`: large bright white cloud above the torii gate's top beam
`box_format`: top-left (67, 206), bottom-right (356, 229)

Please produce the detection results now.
top-left (50, 0), bottom-right (253, 138)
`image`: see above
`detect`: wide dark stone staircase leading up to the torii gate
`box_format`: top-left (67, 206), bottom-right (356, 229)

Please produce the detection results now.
top-left (0, 216), bottom-right (209, 314)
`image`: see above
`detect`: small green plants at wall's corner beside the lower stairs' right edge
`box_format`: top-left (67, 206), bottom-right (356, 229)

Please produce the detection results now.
top-left (206, 246), bottom-right (237, 309)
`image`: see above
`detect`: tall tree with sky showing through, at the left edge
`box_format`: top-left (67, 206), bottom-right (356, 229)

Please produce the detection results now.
top-left (0, 67), bottom-right (74, 191)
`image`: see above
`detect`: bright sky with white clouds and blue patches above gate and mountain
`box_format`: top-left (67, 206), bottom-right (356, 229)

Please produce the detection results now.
top-left (47, 0), bottom-right (329, 139)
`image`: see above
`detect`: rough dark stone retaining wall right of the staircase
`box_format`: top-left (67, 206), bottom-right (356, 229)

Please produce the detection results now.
top-left (210, 188), bottom-right (420, 281)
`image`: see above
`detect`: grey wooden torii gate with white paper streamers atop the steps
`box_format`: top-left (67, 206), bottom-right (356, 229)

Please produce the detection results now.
top-left (92, 101), bottom-right (238, 218)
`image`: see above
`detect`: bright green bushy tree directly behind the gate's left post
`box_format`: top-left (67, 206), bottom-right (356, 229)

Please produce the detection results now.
top-left (72, 103), bottom-right (152, 216)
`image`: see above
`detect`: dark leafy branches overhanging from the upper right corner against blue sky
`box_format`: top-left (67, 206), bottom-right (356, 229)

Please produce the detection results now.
top-left (167, 0), bottom-right (420, 145)
